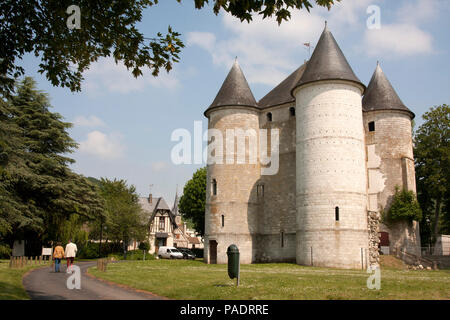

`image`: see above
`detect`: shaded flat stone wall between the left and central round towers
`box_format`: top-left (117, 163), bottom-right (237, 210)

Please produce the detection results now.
top-left (256, 103), bottom-right (297, 262)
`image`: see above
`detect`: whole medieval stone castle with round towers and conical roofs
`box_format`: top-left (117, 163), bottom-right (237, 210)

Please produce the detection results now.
top-left (204, 26), bottom-right (420, 269)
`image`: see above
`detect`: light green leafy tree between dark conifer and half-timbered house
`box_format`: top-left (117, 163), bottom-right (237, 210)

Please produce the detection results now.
top-left (94, 178), bottom-right (149, 251)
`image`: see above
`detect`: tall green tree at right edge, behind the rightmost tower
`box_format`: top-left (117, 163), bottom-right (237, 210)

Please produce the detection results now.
top-left (414, 104), bottom-right (450, 243)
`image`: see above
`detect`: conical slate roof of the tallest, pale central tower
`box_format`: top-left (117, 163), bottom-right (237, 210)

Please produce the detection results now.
top-left (294, 23), bottom-right (365, 93)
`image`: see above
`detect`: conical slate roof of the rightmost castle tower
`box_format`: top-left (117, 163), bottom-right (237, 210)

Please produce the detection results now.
top-left (362, 63), bottom-right (414, 118)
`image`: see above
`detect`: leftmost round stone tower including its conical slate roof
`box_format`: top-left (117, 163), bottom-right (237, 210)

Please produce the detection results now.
top-left (204, 61), bottom-right (260, 263)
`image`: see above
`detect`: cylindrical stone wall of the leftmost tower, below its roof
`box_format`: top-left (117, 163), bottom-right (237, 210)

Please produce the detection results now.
top-left (204, 107), bottom-right (260, 263)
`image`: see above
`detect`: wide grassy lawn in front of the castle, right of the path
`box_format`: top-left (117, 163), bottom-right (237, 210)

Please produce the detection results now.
top-left (89, 256), bottom-right (450, 300)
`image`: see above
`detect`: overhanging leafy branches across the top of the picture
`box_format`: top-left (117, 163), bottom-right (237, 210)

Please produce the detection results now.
top-left (0, 0), bottom-right (340, 93)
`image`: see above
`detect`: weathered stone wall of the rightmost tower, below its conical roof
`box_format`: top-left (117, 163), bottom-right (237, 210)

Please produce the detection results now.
top-left (363, 110), bottom-right (420, 255)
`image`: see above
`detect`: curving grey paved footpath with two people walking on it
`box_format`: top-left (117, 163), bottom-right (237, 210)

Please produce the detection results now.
top-left (23, 262), bottom-right (164, 300)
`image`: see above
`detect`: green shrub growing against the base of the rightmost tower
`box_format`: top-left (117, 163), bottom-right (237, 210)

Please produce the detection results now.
top-left (388, 186), bottom-right (422, 221)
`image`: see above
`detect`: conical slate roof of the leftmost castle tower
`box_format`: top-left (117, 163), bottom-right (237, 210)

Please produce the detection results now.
top-left (205, 59), bottom-right (258, 114)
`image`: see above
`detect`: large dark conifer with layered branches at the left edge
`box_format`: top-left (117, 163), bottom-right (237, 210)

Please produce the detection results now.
top-left (0, 78), bottom-right (103, 252)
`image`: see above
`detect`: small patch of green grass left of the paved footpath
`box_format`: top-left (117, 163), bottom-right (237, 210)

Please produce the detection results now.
top-left (0, 260), bottom-right (51, 300)
